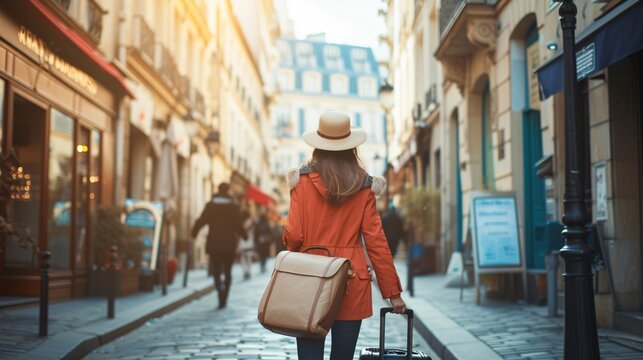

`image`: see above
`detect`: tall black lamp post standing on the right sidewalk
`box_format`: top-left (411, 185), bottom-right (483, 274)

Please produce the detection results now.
top-left (555, 0), bottom-right (600, 360)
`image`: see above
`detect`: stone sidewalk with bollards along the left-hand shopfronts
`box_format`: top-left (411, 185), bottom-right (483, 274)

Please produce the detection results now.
top-left (0, 270), bottom-right (214, 359)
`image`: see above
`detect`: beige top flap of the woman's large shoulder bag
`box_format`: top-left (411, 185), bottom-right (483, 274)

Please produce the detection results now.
top-left (275, 251), bottom-right (350, 277)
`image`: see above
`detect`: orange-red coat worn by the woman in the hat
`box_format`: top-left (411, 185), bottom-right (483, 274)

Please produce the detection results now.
top-left (283, 172), bottom-right (402, 320)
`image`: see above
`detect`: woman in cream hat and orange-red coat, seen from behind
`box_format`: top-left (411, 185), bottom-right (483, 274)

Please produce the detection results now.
top-left (283, 112), bottom-right (406, 360)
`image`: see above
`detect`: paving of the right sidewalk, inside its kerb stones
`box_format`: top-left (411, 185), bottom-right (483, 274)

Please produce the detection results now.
top-left (408, 264), bottom-right (643, 360)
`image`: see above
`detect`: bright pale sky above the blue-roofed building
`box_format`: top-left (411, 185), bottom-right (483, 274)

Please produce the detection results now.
top-left (286, 0), bottom-right (386, 60)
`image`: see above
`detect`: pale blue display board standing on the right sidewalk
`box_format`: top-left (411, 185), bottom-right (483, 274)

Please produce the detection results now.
top-left (467, 192), bottom-right (527, 304)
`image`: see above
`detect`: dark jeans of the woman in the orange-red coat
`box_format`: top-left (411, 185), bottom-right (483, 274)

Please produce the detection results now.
top-left (297, 320), bottom-right (362, 360)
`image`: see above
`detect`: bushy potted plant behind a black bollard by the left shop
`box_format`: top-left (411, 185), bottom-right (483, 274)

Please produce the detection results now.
top-left (89, 207), bottom-right (143, 296)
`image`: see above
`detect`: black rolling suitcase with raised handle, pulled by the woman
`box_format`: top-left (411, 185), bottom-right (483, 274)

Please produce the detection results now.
top-left (359, 307), bottom-right (431, 360)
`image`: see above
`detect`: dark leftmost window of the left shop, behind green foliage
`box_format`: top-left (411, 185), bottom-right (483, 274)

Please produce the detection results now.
top-left (4, 95), bottom-right (47, 267)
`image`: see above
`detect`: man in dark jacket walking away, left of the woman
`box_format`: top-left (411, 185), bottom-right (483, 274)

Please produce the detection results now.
top-left (192, 183), bottom-right (248, 309)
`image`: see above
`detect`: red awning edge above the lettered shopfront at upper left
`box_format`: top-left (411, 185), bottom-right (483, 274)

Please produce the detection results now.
top-left (25, 0), bottom-right (135, 98)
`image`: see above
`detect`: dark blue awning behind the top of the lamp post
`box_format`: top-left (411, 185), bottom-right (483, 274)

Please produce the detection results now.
top-left (536, 0), bottom-right (643, 99)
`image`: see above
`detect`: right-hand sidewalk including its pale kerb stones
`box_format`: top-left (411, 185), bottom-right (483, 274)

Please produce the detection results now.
top-left (396, 262), bottom-right (643, 360)
